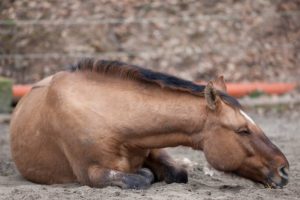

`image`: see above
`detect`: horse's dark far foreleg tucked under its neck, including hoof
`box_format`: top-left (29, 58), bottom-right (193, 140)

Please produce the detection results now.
top-left (144, 149), bottom-right (188, 183)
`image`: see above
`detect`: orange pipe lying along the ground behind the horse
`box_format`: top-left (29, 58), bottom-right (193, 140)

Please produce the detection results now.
top-left (13, 81), bottom-right (297, 99)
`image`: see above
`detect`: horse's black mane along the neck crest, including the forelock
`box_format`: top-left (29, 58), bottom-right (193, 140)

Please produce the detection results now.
top-left (70, 58), bottom-right (241, 108)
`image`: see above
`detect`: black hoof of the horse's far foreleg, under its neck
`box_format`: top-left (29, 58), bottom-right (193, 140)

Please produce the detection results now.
top-left (165, 167), bottom-right (188, 184)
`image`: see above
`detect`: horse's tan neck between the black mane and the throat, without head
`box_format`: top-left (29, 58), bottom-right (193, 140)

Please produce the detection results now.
top-left (76, 73), bottom-right (207, 149)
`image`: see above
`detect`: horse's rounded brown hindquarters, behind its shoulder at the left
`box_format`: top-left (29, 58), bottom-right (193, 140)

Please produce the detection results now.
top-left (10, 73), bottom-right (74, 184)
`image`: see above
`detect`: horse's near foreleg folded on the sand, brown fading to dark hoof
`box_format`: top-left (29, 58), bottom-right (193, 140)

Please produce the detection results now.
top-left (88, 166), bottom-right (154, 189)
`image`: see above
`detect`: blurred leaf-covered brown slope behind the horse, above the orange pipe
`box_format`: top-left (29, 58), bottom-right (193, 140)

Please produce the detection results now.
top-left (0, 0), bottom-right (300, 83)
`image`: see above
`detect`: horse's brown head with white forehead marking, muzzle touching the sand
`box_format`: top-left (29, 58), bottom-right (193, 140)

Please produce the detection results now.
top-left (202, 77), bottom-right (289, 188)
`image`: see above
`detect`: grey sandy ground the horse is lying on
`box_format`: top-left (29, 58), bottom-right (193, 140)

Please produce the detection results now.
top-left (0, 108), bottom-right (300, 200)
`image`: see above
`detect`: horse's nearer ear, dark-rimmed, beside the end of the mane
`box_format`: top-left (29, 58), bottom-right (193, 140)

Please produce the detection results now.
top-left (204, 81), bottom-right (220, 111)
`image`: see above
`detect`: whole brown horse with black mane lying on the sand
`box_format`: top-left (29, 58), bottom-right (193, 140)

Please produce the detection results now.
top-left (11, 59), bottom-right (289, 189)
